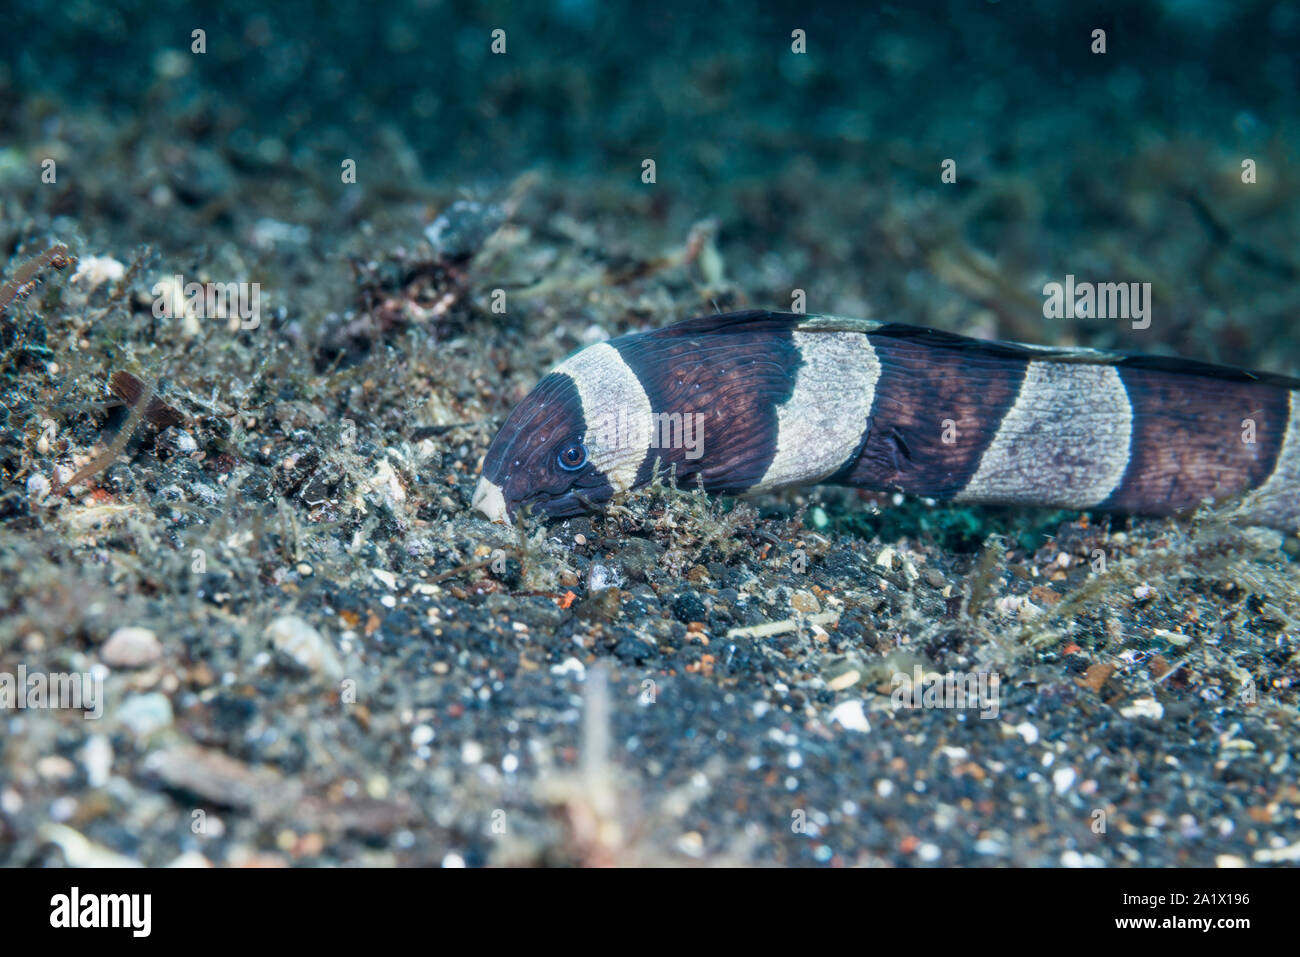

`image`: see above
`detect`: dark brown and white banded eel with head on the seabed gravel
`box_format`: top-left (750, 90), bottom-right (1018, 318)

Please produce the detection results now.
top-left (473, 311), bottom-right (1300, 532)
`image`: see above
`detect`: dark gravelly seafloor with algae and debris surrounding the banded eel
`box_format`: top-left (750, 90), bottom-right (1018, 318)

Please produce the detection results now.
top-left (0, 3), bottom-right (1300, 866)
